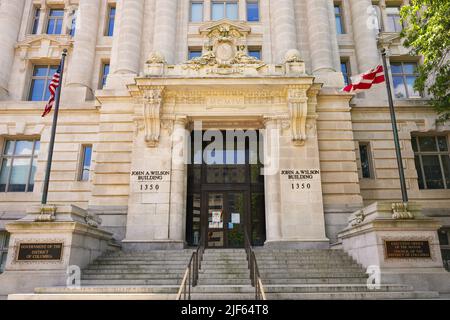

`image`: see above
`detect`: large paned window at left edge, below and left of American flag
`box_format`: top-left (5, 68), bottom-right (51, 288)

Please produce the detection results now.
top-left (0, 140), bottom-right (40, 192)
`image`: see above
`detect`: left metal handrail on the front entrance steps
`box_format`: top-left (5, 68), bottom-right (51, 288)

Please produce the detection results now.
top-left (176, 235), bottom-right (205, 300)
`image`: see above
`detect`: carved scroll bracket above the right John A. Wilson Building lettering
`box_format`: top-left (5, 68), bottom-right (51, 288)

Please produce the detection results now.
top-left (288, 86), bottom-right (308, 146)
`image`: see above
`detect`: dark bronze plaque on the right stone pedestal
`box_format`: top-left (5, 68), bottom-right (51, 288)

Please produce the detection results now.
top-left (384, 240), bottom-right (431, 259)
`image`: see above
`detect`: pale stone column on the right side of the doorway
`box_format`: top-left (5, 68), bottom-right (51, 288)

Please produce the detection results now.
top-left (264, 118), bottom-right (282, 243)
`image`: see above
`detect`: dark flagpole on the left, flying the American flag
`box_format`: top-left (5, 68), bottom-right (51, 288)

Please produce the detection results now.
top-left (41, 49), bottom-right (67, 205)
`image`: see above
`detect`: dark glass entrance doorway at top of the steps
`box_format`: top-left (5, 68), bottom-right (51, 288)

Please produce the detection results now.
top-left (186, 131), bottom-right (266, 248)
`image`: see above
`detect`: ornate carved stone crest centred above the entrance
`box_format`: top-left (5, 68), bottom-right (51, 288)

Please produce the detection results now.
top-left (184, 21), bottom-right (265, 74)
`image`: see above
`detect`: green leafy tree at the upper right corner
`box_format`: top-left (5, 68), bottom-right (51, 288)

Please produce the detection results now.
top-left (400, 0), bottom-right (450, 121)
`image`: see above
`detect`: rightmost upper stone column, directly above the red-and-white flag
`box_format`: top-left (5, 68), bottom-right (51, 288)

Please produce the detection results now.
top-left (349, 0), bottom-right (380, 73)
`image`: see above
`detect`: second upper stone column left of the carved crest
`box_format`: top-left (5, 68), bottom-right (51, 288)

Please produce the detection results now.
top-left (114, 0), bottom-right (145, 74)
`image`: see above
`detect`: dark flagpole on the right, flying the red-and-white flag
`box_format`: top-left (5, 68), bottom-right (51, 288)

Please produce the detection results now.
top-left (381, 48), bottom-right (408, 203)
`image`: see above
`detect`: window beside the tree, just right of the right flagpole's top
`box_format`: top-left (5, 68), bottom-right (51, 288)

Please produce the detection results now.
top-left (391, 62), bottom-right (421, 99)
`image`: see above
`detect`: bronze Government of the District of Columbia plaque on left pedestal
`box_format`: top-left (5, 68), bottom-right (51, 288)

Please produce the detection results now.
top-left (17, 243), bottom-right (64, 261)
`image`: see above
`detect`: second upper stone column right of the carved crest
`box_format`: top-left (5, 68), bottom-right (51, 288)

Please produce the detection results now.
top-left (306, 0), bottom-right (336, 74)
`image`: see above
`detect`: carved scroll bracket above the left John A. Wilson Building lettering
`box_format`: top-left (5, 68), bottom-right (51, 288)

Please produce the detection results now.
top-left (143, 87), bottom-right (164, 148)
